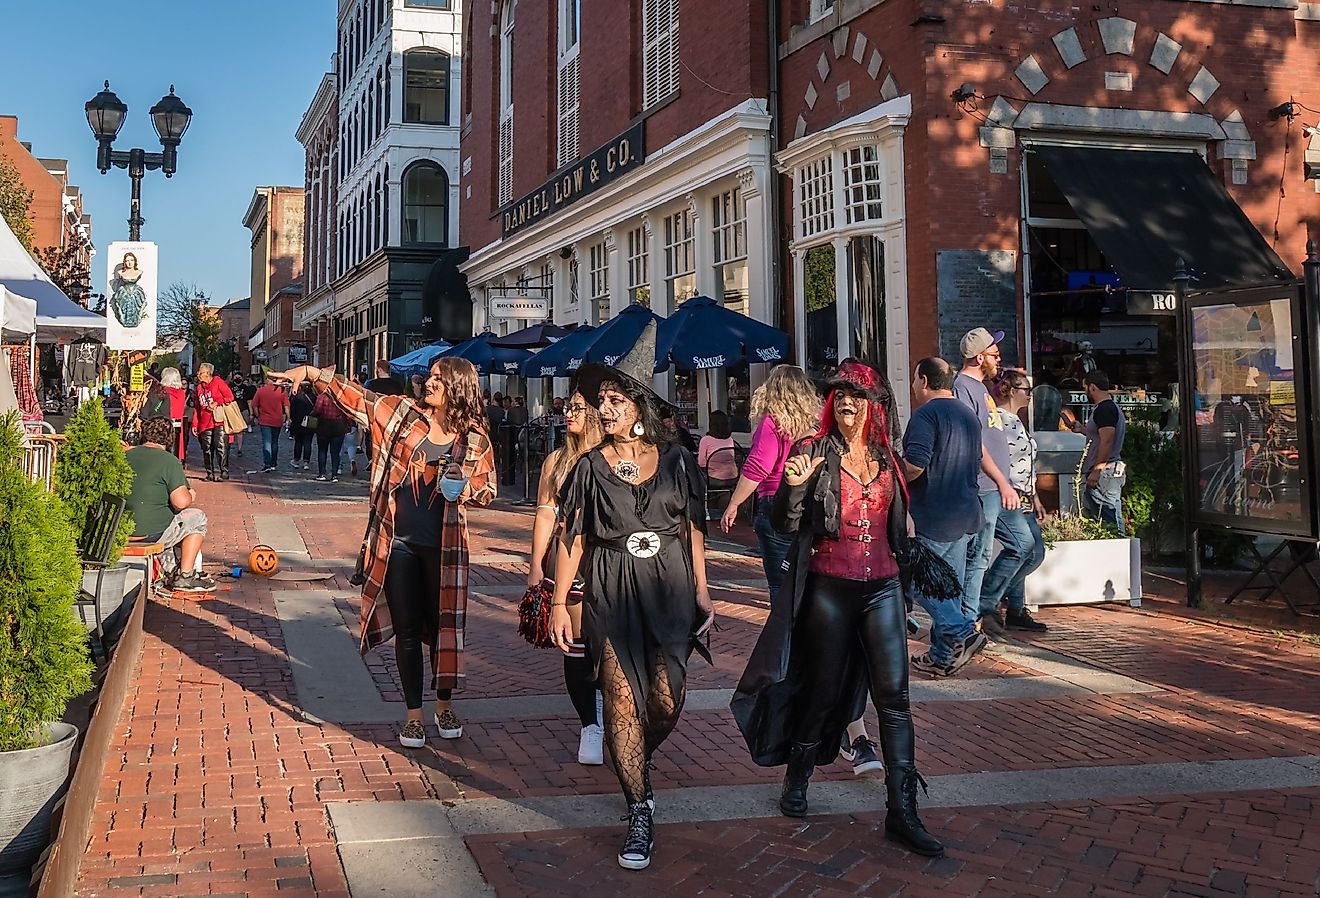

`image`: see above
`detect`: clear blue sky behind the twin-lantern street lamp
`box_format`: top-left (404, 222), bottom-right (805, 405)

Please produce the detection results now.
top-left (0, 0), bottom-right (337, 302)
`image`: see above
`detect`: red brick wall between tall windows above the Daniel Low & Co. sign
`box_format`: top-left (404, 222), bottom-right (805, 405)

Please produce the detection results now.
top-left (461, 0), bottom-right (768, 248)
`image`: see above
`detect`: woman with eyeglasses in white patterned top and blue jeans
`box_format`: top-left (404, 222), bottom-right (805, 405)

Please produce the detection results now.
top-left (981, 368), bottom-right (1049, 633)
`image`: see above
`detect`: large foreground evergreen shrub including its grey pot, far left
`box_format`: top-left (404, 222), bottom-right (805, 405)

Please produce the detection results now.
top-left (0, 412), bottom-right (91, 874)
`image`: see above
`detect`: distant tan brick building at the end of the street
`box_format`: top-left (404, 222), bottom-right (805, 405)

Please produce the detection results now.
top-left (243, 188), bottom-right (308, 371)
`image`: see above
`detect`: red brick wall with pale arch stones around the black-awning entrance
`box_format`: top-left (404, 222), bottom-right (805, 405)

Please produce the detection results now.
top-left (781, 0), bottom-right (1320, 355)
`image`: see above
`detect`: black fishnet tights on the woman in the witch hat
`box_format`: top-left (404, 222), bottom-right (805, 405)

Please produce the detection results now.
top-left (599, 642), bottom-right (686, 804)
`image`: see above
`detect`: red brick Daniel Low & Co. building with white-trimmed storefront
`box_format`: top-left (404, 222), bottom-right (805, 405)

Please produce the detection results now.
top-left (462, 0), bottom-right (1320, 419)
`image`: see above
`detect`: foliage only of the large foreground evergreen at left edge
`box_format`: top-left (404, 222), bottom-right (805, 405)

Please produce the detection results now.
top-left (0, 412), bottom-right (91, 751)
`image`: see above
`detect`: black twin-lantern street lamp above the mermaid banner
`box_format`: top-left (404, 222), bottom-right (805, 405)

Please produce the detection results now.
top-left (83, 81), bottom-right (193, 240)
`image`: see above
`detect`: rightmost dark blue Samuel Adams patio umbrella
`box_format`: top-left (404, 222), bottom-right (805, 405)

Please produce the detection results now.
top-left (654, 296), bottom-right (788, 370)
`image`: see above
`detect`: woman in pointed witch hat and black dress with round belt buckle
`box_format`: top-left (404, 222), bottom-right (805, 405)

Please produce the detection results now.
top-left (550, 324), bottom-right (714, 870)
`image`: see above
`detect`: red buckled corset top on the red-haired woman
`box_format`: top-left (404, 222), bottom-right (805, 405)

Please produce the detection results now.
top-left (810, 467), bottom-right (899, 581)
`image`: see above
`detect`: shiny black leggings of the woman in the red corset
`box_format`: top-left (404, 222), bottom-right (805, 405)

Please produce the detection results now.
top-left (793, 573), bottom-right (915, 770)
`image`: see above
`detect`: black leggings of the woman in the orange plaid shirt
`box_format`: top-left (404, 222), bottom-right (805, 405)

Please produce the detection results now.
top-left (385, 539), bottom-right (453, 710)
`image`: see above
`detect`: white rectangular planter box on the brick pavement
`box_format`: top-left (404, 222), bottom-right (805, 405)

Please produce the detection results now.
top-left (1027, 537), bottom-right (1142, 607)
